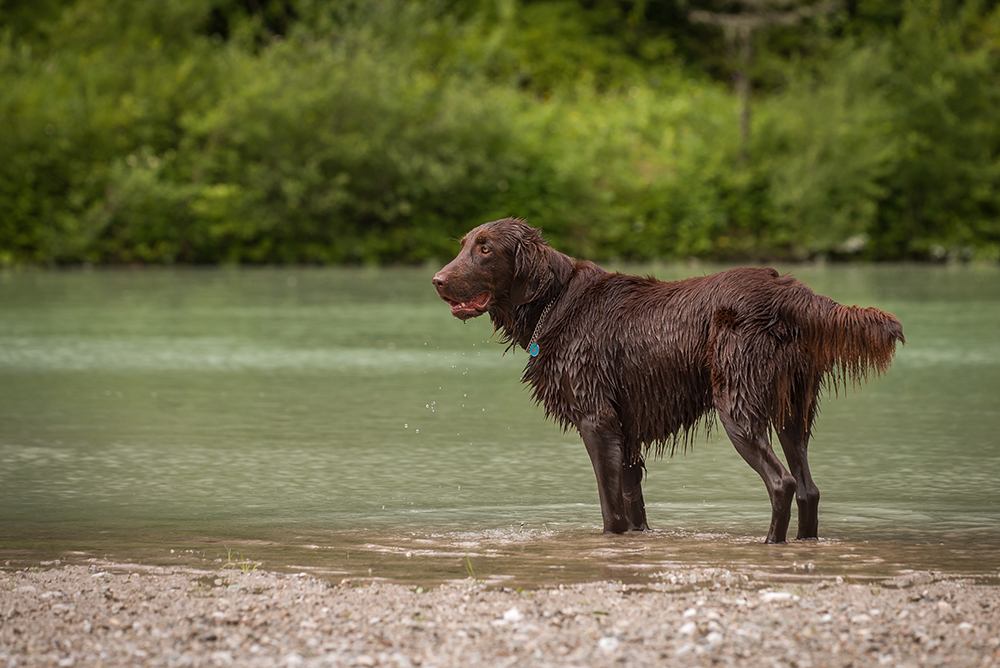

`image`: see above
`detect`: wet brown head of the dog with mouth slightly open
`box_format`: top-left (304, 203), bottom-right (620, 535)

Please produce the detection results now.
top-left (433, 218), bottom-right (552, 320)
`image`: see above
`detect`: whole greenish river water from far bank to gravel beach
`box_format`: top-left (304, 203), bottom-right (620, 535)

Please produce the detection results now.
top-left (0, 266), bottom-right (1000, 585)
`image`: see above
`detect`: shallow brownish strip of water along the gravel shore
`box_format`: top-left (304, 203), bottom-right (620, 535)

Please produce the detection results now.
top-left (5, 526), bottom-right (1000, 588)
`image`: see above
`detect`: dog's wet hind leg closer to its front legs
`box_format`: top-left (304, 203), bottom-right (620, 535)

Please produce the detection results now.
top-left (716, 401), bottom-right (795, 543)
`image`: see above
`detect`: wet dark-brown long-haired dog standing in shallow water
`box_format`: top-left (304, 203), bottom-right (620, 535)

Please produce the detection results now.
top-left (434, 218), bottom-right (904, 543)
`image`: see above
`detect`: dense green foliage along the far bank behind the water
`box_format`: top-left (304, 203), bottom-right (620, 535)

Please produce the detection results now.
top-left (0, 0), bottom-right (1000, 263)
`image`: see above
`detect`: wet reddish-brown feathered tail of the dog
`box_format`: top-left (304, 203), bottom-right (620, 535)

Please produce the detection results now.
top-left (803, 296), bottom-right (906, 392)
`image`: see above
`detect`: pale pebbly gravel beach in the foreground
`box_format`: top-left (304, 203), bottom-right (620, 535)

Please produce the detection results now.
top-left (0, 560), bottom-right (1000, 668)
